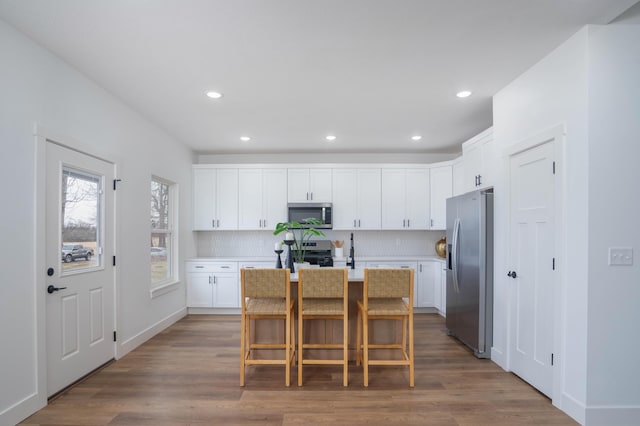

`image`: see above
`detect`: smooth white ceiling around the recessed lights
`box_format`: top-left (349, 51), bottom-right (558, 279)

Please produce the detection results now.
top-left (0, 0), bottom-right (637, 153)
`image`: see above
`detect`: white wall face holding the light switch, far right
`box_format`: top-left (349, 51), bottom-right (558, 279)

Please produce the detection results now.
top-left (587, 25), bottom-right (640, 424)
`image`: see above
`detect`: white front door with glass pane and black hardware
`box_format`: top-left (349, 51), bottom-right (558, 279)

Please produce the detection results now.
top-left (42, 142), bottom-right (115, 396)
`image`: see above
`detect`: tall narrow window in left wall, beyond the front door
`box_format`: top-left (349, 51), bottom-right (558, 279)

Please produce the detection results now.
top-left (150, 177), bottom-right (176, 288)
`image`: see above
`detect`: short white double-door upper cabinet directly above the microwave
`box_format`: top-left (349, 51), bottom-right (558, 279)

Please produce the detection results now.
top-left (287, 169), bottom-right (331, 203)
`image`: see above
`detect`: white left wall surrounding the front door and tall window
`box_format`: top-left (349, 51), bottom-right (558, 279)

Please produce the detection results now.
top-left (0, 21), bottom-right (195, 424)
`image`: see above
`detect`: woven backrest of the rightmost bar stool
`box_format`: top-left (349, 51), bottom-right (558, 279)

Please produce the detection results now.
top-left (364, 268), bottom-right (413, 299)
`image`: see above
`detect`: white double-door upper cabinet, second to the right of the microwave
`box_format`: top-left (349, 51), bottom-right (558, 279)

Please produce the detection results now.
top-left (382, 168), bottom-right (431, 230)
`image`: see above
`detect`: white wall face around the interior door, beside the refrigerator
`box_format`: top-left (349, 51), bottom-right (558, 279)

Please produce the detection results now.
top-left (493, 29), bottom-right (588, 420)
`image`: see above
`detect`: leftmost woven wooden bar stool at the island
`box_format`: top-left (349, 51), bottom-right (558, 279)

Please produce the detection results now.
top-left (240, 269), bottom-right (295, 386)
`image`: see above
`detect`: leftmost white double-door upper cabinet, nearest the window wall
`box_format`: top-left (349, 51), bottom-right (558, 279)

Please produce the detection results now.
top-left (192, 167), bottom-right (238, 231)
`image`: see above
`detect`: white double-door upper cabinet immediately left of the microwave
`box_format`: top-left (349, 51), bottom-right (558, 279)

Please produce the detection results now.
top-left (238, 169), bottom-right (287, 230)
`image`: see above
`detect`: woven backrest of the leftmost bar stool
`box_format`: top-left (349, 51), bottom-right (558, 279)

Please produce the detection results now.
top-left (240, 269), bottom-right (291, 299)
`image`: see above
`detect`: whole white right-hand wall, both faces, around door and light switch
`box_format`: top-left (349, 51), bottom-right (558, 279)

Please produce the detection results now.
top-left (494, 25), bottom-right (640, 425)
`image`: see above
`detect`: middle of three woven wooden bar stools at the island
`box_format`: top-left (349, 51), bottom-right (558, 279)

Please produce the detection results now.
top-left (298, 268), bottom-right (349, 386)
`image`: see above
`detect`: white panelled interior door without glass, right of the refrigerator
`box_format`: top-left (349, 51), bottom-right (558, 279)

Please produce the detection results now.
top-left (509, 142), bottom-right (555, 397)
